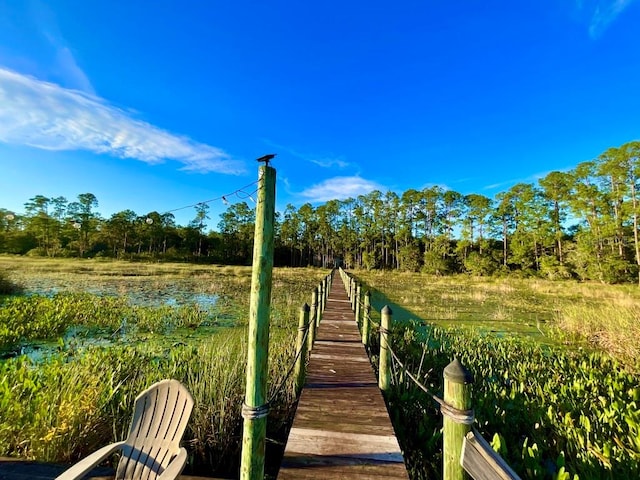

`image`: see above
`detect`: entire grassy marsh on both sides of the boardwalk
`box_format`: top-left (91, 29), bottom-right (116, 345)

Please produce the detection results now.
top-left (5, 257), bottom-right (640, 480)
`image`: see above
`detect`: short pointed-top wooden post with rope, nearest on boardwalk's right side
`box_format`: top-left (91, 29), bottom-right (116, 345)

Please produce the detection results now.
top-left (442, 358), bottom-right (473, 480)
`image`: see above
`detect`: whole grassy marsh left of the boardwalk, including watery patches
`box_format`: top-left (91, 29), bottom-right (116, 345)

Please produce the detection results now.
top-left (0, 257), bottom-right (327, 477)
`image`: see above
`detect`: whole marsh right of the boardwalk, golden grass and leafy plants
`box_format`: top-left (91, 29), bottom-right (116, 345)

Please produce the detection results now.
top-left (354, 271), bottom-right (640, 480)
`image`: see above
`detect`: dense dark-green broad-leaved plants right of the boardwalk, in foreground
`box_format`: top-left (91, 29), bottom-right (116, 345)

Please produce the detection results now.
top-left (388, 325), bottom-right (640, 479)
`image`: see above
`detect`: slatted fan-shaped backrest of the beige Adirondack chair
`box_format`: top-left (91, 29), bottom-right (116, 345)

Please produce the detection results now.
top-left (115, 380), bottom-right (193, 480)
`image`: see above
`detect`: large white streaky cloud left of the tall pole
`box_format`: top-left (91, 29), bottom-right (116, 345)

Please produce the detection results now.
top-left (0, 67), bottom-right (244, 174)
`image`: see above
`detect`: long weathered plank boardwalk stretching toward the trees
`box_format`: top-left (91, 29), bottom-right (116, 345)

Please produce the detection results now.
top-left (278, 275), bottom-right (408, 480)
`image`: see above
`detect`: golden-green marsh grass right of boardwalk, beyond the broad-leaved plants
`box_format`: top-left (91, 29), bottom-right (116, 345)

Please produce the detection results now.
top-left (354, 271), bottom-right (640, 360)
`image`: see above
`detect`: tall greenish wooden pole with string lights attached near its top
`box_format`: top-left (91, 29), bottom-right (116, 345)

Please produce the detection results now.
top-left (240, 165), bottom-right (276, 480)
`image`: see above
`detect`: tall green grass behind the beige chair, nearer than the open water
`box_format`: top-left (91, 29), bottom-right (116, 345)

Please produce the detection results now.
top-left (0, 328), bottom-right (294, 473)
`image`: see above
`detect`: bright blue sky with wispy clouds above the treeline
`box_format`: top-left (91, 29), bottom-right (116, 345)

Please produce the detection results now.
top-left (0, 0), bottom-right (640, 228)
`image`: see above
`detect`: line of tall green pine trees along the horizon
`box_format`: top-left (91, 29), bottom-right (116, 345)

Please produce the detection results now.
top-left (0, 141), bottom-right (640, 283)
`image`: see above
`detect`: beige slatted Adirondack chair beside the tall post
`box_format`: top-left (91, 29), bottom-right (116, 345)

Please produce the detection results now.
top-left (56, 380), bottom-right (193, 480)
